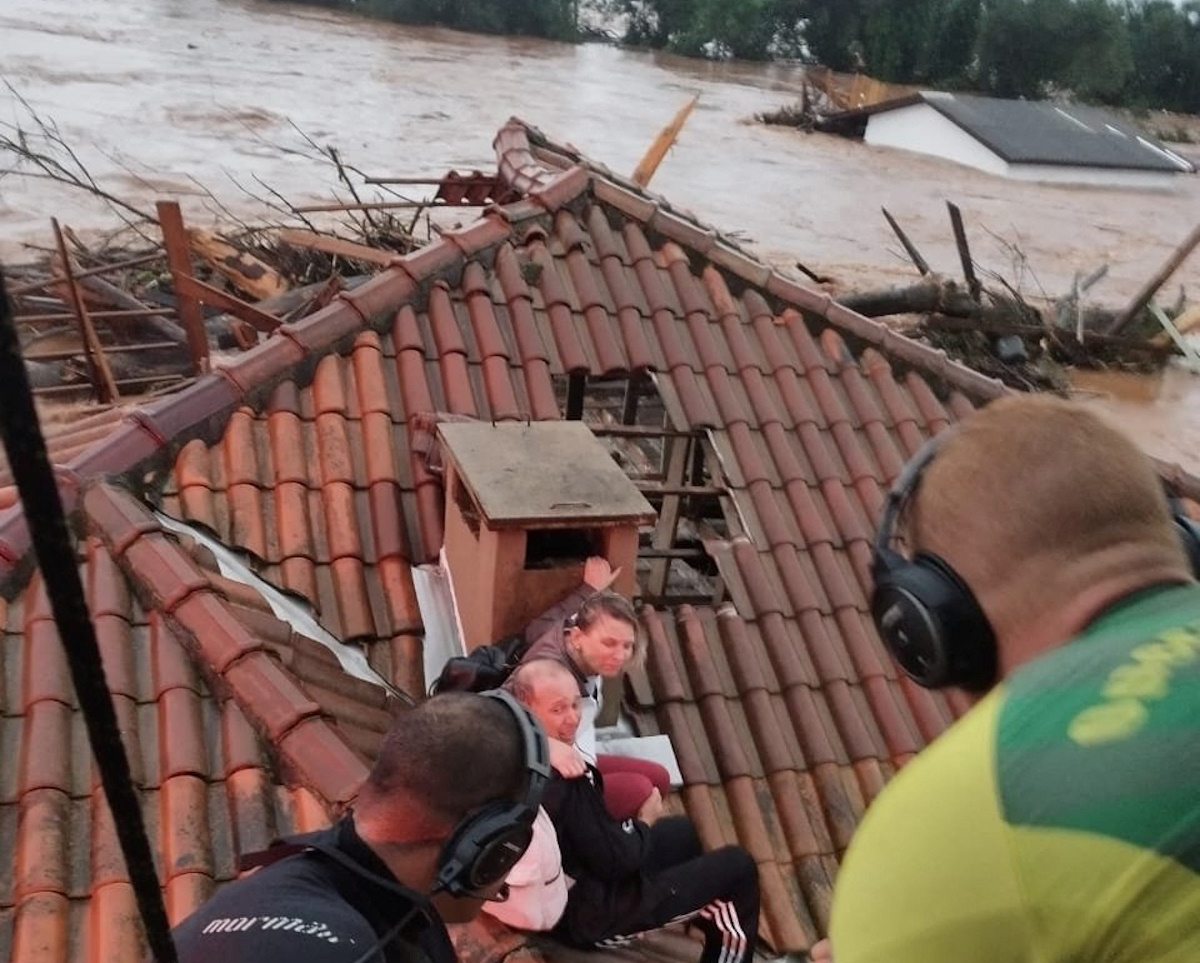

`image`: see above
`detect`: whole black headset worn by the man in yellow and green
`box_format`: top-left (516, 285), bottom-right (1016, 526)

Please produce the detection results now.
top-left (871, 429), bottom-right (1200, 692)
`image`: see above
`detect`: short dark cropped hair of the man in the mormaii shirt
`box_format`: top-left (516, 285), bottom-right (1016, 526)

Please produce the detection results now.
top-left (364, 692), bottom-right (526, 821)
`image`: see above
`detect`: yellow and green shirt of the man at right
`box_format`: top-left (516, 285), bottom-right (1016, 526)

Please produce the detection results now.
top-left (830, 585), bottom-right (1200, 963)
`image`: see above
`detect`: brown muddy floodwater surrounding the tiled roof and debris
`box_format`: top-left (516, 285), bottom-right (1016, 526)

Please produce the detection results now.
top-left (0, 0), bottom-right (1200, 471)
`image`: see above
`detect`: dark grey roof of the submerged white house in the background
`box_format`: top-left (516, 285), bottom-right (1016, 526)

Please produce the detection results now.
top-left (824, 90), bottom-right (1195, 173)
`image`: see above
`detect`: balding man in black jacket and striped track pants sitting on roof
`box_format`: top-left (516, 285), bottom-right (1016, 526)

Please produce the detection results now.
top-left (505, 659), bottom-right (760, 963)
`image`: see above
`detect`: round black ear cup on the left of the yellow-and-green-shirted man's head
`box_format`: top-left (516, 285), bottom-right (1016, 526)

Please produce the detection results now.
top-left (871, 552), bottom-right (996, 690)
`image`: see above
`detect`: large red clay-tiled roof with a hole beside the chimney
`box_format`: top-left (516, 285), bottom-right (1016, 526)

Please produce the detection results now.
top-left (0, 121), bottom-right (1198, 963)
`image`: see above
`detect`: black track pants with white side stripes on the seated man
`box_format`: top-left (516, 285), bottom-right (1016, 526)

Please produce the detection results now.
top-left (598, 817), bottom-right (758, 963)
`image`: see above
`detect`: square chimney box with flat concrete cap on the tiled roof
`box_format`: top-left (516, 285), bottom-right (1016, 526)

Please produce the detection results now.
top-left (439, 421), bottom-right (654, 651)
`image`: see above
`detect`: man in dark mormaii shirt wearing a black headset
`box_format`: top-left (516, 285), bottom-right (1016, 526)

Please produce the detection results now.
top-left (166, 693), bottom-right (550, 963)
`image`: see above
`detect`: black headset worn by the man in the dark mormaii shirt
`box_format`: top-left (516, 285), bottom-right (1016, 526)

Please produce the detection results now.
top-left (433, 689), bottom-right (550, 896)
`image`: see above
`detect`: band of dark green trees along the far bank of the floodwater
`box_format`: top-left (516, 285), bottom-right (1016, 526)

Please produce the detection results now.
top-left (276, 0), bottom-right (1200, 113)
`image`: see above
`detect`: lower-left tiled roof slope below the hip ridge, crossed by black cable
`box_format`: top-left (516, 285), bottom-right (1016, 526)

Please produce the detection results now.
top-left (0, 538), bottom-right (325, 963)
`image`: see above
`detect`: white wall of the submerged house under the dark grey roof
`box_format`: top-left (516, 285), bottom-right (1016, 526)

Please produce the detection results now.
top-left (863, 103), bottom-right (1177, 190)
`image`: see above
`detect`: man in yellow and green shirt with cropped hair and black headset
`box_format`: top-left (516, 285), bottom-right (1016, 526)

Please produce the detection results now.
top-left (812, 396), bottom-right (1200, 963)
